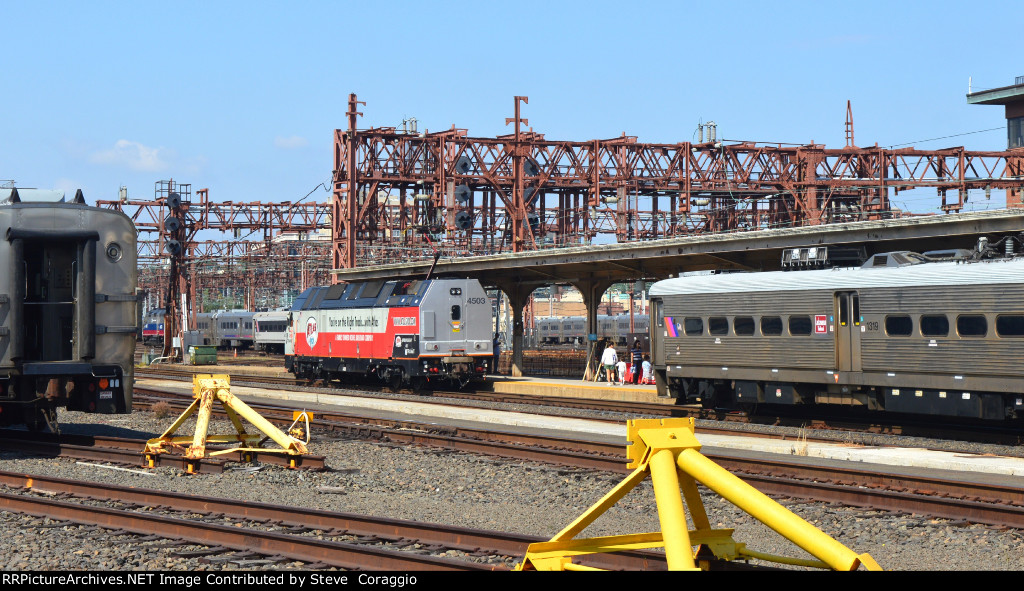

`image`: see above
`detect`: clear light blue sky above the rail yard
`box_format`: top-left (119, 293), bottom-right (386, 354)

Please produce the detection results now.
top-left (0, 0), bottom-right (1024, 211)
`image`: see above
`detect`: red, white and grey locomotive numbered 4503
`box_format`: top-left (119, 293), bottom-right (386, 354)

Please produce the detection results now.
top-left (285, 279), bottom-right (494, 388)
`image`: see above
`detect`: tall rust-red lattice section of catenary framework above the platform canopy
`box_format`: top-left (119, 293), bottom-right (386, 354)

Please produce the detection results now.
top-left (332, 94), bottom-right (1024, 268)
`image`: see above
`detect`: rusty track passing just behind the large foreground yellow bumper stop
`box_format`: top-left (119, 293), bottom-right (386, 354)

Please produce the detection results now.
top-left (130, 387), bottom-right (1024, 529)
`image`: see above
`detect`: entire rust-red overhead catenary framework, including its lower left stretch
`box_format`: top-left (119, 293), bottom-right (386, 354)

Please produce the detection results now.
top-left (99, 90), bottom-right (1024, 366)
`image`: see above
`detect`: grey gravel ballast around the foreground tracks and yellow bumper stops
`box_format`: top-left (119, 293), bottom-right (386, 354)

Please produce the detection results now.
top-left (0, 403), bottom-right (1024, 571)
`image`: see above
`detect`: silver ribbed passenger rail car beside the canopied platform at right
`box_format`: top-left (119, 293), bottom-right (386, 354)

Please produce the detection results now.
top-left (650, 247), bottom-right (1024, 420)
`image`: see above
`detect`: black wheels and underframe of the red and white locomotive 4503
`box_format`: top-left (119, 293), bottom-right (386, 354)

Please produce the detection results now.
top-left (285, 355), bottom-right (490, 391)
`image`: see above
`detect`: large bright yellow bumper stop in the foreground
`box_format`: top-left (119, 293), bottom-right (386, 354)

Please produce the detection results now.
top-left (516, 419), bottom-right (882, 571)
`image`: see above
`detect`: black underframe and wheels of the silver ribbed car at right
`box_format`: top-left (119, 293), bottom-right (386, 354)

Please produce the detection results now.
top-left (654, 370), bottom-right (1024, 421)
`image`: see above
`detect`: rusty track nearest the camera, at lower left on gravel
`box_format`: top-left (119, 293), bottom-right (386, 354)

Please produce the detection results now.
top-left (0, 472), bottom-right (499, 571)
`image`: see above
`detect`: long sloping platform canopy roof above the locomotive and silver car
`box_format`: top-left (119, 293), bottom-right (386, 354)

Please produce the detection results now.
top-left (332, 209), bottom-right (1024, 288)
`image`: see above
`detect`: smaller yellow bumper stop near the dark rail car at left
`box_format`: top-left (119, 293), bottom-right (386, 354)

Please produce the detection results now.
top-left (143, 374), bottom-right (309, 473)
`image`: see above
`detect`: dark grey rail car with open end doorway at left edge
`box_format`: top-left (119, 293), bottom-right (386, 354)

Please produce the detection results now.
top-left (0, 189), bottom-right (138, 429)
